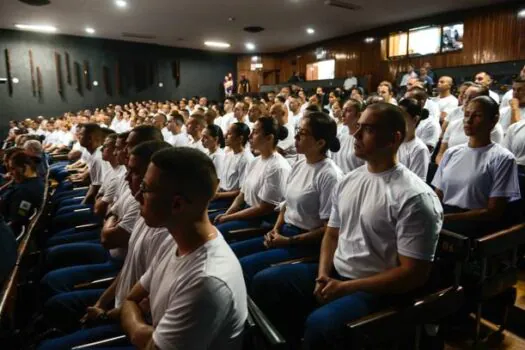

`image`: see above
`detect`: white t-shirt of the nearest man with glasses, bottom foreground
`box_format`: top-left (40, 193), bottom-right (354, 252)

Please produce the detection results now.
top-left (140, 236), bottom-right (248, 350)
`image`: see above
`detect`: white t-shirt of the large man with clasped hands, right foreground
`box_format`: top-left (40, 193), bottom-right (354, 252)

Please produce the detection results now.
top-left (328, 164), bottom-right (443, 279)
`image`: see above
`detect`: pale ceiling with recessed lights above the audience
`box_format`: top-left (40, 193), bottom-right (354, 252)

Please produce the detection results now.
top-left (0, 0), bottom-right (509, 53)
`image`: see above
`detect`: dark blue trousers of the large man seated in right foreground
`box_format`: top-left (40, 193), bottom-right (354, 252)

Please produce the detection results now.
top-left (251, 264), bottom-right (391, 349)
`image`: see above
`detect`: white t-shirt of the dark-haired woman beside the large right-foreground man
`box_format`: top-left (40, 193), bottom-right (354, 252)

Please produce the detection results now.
top-left (284, 158), bottom-right (343, 231)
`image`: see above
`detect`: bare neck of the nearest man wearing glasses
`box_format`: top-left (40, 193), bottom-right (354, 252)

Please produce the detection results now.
top-left (168, 214), bottom-right (217, 257)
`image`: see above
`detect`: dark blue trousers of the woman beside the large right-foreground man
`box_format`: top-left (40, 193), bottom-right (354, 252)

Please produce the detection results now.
top-left (231, 224), bottom-right (319, 288)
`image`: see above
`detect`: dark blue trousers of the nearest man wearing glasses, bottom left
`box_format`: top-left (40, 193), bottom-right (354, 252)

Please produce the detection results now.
top-left (38, 324), bottom-right (127, 350)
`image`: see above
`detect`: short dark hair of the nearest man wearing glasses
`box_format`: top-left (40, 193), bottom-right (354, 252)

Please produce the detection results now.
top-left (151, 147), bottom-right (218, 202)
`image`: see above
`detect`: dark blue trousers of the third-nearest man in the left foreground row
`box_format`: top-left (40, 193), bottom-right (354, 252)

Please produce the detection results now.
top-left (41, 259), bottom-right (123, 298)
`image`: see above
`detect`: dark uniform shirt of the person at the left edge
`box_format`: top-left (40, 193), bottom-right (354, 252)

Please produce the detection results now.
top-left (0, 177), bottom-right (45, 233)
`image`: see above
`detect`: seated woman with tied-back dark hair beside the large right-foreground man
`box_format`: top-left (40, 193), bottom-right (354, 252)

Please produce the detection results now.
top-left (231, 112), bottom-right (343, 286)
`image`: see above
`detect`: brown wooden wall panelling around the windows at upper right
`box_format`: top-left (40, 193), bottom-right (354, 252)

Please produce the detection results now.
top-left (236, 5), bottom-right (525, 91)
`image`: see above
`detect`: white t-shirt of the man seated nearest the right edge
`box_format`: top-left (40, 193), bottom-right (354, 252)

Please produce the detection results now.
top-left (432, 143), bottom-right (520, 209)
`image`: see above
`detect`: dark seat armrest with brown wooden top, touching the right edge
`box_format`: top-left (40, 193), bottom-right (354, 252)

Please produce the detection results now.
top-left (475, 223), bottom-right (525, 258)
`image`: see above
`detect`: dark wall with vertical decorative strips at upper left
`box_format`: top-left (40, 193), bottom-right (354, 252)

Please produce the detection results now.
top-left (0, 30), bottom-right (237, 123)
